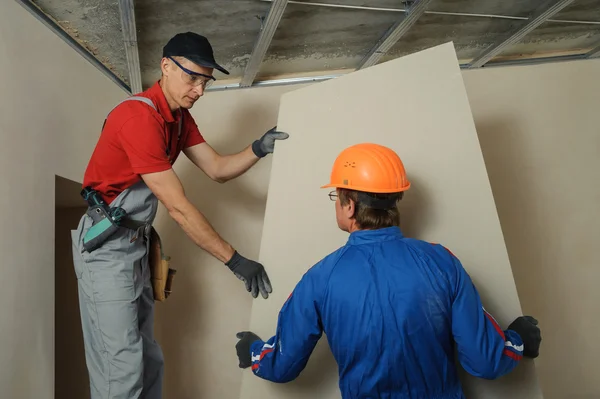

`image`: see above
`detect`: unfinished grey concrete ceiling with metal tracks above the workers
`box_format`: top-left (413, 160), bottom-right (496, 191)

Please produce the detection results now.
top-left (23, 0), bottom-right (600, 88)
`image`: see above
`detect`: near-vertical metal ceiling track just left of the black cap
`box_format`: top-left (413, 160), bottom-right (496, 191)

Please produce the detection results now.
top-left (119, 0), bottom-right (143, 94)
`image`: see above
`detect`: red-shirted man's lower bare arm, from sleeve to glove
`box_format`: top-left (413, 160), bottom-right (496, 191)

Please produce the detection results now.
top-left (142, 169), bottom-right (235, 263)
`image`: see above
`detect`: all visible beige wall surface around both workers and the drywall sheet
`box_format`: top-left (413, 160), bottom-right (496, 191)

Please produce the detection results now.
top-left (0, 2), bottom-right (600, 399)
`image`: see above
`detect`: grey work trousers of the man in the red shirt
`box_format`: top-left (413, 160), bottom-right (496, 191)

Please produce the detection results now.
top-left (71, 183), bottom-right (163, 399)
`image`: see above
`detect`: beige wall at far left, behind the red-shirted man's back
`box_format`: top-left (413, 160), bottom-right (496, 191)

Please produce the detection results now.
top-left (0, 1), bottom-right (125, 399)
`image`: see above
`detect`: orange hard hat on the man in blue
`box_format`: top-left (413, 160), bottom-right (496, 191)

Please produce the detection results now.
top-left (321, 143), bottom-right (410, 193)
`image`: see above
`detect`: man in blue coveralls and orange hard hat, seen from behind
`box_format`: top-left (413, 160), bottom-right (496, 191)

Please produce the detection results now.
top-left (236, 144), bottom-right (541, 399)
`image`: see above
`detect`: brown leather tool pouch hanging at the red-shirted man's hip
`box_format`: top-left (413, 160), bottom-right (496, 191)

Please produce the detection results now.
top-left (148, 227), bottom-right (177, 302)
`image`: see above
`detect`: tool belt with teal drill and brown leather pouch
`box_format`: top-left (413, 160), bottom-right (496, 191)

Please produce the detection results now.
top-left (83, 190), bottom-right (177, 302)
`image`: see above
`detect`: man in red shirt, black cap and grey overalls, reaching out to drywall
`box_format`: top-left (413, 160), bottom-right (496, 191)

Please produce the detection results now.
top-left (72, 32), bottom-right (288, 399)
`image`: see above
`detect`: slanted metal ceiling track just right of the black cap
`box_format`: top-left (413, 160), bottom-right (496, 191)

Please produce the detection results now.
top-left (240, 0), bottom-right (288, 87)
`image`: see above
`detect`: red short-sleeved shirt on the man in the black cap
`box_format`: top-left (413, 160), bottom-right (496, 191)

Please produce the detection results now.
top-left (83, 82), bottom-right (204, 203)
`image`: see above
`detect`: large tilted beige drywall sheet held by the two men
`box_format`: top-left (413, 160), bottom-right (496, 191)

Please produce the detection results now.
top-left (240, 43), bottom-right (542, 399)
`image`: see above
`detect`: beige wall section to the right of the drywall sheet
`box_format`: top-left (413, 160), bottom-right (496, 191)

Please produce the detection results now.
top-left (464, 60), bottom-right (600, 399)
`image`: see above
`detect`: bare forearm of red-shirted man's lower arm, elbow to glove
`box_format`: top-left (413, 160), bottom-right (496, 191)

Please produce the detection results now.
top-left (169, 202), bottom-right (235, 263)
